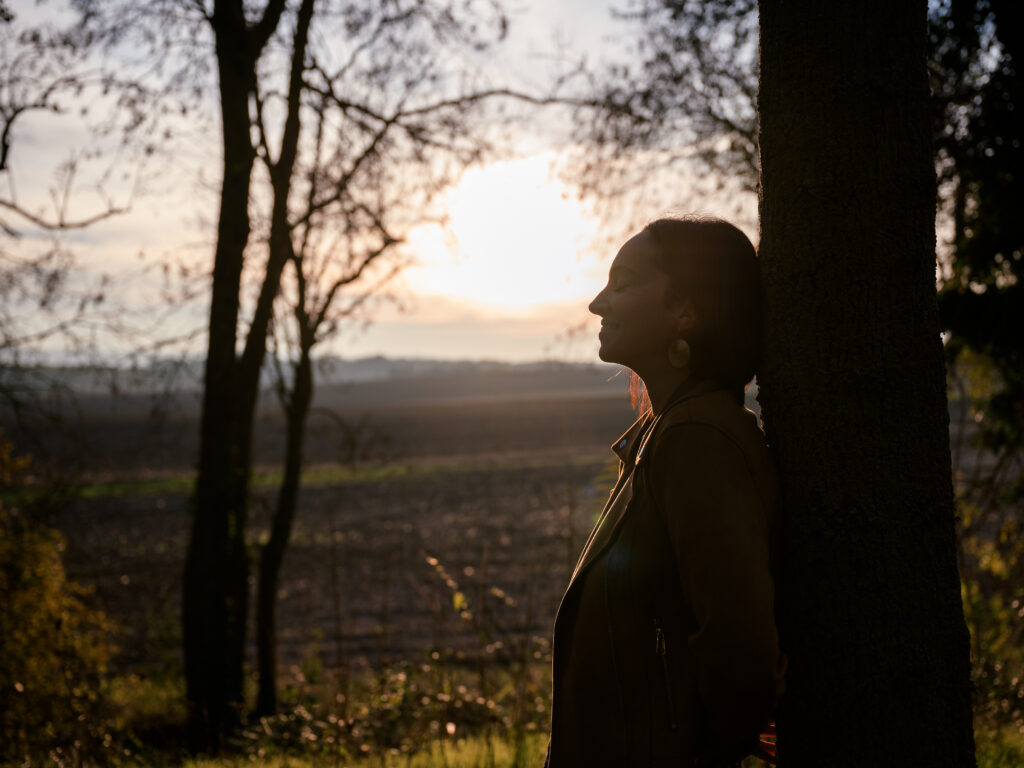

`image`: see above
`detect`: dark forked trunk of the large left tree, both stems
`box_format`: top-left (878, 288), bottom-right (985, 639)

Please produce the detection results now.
top-left (182, 0), bottom-right (313, 752)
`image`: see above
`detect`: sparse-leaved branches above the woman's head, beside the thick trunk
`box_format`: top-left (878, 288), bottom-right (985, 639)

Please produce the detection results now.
top-left (566, 0), bottom-right (758, 223)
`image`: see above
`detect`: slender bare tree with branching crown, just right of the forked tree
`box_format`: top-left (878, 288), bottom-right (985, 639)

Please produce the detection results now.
top-left (249, 90), bottom-right (401, 716)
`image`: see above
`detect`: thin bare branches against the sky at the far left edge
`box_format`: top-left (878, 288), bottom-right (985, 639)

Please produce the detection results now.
top-left (0, 6), bottom-right (144, 462)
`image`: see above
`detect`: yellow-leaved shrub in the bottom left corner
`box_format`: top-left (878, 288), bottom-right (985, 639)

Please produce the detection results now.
top-left (0, 436), bottom-right (113, 764)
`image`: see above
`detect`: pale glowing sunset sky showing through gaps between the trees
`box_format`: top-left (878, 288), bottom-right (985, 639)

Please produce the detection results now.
top-left (4, 0), bottom-right (753, 360)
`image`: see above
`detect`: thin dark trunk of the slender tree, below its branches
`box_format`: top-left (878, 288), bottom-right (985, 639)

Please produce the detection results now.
top-left (256, 343), bottom-right (313, 717)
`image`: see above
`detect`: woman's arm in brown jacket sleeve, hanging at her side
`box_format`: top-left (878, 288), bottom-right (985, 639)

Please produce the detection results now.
top-left (651, 423), bottom-right (784, 761)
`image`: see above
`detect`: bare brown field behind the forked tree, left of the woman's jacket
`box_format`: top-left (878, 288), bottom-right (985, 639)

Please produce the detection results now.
top-left (57, 398), bottom-right (632, 671)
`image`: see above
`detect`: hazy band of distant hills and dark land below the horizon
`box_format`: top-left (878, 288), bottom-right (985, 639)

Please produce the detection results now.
top-left (0, 357), bottom-right (635, 476)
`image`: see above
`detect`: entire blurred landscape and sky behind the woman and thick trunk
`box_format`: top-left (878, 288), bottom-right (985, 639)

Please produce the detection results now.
top-left (0, 0), bottom-right (1024, 766)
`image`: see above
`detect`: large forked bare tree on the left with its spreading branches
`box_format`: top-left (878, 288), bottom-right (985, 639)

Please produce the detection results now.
top-left (48, 0), bottom-right (544, 750)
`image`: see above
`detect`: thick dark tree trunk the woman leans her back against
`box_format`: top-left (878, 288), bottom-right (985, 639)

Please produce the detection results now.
top-left (759, 0), bottom-right (974, 768)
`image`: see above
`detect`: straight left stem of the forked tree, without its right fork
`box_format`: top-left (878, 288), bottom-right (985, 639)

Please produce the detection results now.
top-left (182, 4), bottom-right (255, 752)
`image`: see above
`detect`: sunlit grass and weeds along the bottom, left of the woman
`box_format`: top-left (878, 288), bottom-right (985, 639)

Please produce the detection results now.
top-left (102, 655), bottom-right (550, 768)
